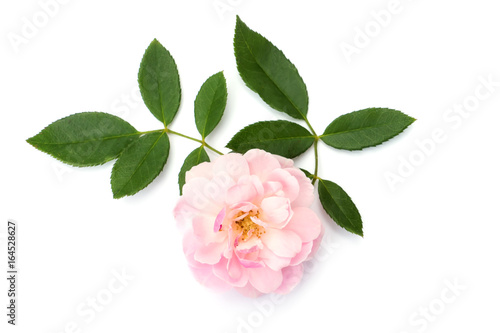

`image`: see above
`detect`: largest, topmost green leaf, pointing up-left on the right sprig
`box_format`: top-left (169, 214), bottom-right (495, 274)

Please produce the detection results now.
top-left (234, 16), bottom-right (309, 119)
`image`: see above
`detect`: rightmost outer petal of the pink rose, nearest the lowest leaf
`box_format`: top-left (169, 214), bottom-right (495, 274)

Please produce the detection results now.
top-left (285, 207), bottom-right (322, 242)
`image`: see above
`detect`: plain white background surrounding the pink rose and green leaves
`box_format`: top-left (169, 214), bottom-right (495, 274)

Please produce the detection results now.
top-left (0, 0), bottom-right (500, 333)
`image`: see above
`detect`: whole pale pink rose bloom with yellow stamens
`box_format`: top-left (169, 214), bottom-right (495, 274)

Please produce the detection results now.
top-left (174, 149), bottom-right (323, 297)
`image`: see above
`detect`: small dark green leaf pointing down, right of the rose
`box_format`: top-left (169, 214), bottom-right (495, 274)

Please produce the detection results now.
top-left (318, 179), bottom-right (363, 237)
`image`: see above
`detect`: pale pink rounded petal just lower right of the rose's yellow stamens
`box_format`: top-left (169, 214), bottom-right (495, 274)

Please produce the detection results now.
top-left (260, 228), bottom-right (302, 258)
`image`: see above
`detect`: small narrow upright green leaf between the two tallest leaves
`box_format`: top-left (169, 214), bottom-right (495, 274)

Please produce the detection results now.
top-left (194, 72), bottom-right (227, 139)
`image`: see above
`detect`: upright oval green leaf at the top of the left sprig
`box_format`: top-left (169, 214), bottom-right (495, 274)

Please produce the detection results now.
top-left (139, 39), bottom-right (181, 127)
